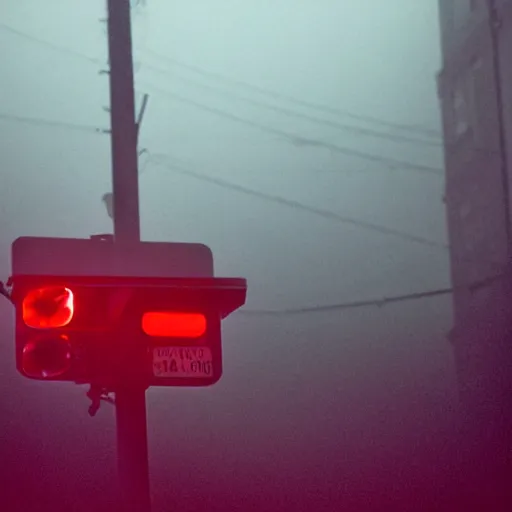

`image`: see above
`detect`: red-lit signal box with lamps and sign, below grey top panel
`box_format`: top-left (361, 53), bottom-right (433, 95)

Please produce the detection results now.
top-left (12, 275), bottom-right (247, 388)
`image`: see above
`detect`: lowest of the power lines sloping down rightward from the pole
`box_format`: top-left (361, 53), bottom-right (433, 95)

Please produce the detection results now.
top-left (151, 154), bottom-right (448, 249)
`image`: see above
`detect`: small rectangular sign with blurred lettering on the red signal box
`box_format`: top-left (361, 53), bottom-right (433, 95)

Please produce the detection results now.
top-left (153, 347), bottom-right (213, 378)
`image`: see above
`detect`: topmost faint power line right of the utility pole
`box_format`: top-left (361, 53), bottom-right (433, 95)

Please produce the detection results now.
top-left (145, 49), bottom-right (440, 139)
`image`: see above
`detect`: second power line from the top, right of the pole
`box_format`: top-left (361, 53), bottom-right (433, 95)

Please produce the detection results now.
top-left (144, 59), bottom-right (443, 148)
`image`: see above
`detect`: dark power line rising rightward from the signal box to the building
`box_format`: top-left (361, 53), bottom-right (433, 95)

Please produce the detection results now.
top-left (239, 275), bottom-right (503, 316)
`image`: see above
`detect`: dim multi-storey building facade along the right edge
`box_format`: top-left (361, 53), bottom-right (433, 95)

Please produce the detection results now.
top-left (438, 0), bottom-right (512, 428)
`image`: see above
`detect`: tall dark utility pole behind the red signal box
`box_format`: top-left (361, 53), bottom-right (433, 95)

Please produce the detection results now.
top-left (107, 0), bottom-right (151, 512)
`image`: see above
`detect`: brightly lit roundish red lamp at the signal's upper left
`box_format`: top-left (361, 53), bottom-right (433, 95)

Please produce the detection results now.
top-left (22, 286), bottom-right (75, 329)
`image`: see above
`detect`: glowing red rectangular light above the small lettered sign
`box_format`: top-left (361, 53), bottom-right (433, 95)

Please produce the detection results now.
top-left (142, 311), bottom-right (206, 338)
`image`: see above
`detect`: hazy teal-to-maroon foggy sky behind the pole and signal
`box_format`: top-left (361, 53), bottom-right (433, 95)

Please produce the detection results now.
top-left (0, 0), bottom-right (472, 512)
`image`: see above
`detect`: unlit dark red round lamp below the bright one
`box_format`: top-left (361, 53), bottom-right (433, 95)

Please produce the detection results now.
top-left (21, 336), bottom-right (71, 379)
